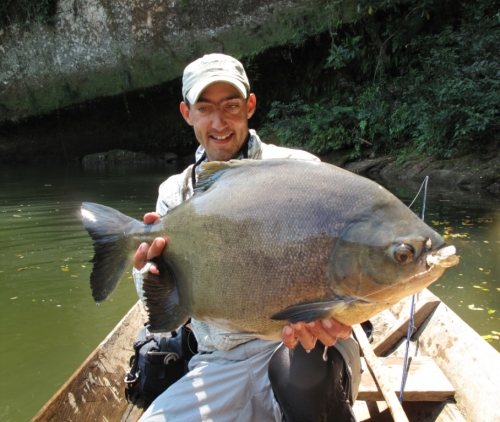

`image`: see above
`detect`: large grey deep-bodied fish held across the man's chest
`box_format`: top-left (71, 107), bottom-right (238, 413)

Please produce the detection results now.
top-left (82, 160), bottom-right (458, 339)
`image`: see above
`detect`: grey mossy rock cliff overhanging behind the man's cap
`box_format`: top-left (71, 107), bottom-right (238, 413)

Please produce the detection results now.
top-left (0, 0), bottom-right (346, 124)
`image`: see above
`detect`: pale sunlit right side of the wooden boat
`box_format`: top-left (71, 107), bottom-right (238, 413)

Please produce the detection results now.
top-left (417, 303), bottom-right (500, 422)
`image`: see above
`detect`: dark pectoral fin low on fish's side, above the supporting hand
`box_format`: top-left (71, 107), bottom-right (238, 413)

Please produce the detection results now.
top-left (271, 299), bottom-right (347, 324)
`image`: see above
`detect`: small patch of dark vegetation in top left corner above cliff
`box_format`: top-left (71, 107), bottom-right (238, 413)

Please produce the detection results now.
top-left (0, 0), bottom-right (57, 28)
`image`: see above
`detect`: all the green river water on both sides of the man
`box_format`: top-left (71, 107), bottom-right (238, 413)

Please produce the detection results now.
top-left (0, 164), bottom-right (500, 422)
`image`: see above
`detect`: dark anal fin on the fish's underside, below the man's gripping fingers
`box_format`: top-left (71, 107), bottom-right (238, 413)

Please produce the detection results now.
top-left (142, 259), bottom-right (189, 333)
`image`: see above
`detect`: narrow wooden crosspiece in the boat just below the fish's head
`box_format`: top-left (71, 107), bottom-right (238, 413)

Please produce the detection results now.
top-left (372, 290), bottom-right (441, 356)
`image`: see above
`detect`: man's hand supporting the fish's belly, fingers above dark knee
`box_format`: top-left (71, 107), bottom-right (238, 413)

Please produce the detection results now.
top-left (281, 318), bottom-right (352, 350)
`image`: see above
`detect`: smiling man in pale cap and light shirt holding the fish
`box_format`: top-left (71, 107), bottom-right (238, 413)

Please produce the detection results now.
top-left (134, 54), bottom-right (359, 422)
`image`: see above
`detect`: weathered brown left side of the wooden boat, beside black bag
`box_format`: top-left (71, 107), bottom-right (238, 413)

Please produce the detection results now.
top-left (32, 302), bottom-right (147, 422)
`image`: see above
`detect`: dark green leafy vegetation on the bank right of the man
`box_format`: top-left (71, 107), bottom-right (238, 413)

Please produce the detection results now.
top-left (256, 0), bottom-right (500, 158)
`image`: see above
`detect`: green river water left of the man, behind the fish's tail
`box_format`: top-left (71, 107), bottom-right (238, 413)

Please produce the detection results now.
top-left (0, 165), bottom-right (184, 422)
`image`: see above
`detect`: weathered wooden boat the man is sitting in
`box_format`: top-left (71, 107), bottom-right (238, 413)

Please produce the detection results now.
top-left (32, 290), bottom-right (500, 422)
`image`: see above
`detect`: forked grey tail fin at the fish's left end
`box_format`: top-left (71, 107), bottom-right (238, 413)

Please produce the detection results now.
top-left (81, 202), bottom-right (144, 303)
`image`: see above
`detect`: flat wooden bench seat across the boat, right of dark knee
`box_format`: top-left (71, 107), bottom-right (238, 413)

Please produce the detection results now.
top-left (358, 356), bottom-right (455, 401)
